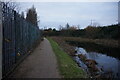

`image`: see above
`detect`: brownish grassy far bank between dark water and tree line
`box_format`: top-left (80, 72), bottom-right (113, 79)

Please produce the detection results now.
top-left (63, 37), bottom-right (118, 48)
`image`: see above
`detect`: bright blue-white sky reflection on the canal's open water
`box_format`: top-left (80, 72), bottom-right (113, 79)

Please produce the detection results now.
top-left (76, 47), bottom-right (120, 78)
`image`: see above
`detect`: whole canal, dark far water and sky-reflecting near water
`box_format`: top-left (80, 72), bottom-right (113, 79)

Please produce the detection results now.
top-left (67, 42), bottom-right (120, 78)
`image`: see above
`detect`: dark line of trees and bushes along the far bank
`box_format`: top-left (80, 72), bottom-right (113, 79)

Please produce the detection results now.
top-left (44, 23), bottom-right (119, 39)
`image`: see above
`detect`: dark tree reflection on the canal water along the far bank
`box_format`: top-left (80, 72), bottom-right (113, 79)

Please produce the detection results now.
top-left (67, 41), bottom-right (120, 60)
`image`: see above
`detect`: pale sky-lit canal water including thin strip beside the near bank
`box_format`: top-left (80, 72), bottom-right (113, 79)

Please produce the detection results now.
top-left (74, 47), bottom-right (120, 78)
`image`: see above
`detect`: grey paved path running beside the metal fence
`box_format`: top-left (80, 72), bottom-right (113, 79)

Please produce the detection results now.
top-left (9, 39), bottom-right (60, 78)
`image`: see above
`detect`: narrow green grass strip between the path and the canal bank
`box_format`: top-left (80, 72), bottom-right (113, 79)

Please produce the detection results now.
top-left (47, 38), bottom-right (87, 78)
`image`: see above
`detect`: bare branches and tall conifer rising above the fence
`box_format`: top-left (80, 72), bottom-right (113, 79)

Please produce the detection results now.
top-left (0, 0), bottom-right (39, 26)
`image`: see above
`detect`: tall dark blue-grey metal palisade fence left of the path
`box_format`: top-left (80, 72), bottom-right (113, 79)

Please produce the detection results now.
top-left (1, 3), bottom-right (42, 77)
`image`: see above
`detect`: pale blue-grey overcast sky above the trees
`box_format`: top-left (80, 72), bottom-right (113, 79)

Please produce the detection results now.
top-left (20, 2), bottom-right (118, 29)
